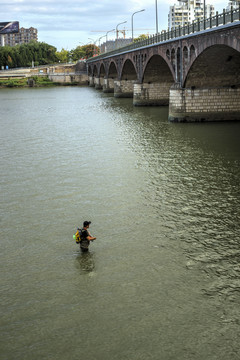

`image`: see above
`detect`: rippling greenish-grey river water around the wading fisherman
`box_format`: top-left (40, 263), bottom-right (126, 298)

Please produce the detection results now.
top-left (0, 87), bottom-right (240, 360)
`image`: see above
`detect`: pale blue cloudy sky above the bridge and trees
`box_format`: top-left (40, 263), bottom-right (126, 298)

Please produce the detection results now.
top-left (0, 0), bottom-right (231, 50)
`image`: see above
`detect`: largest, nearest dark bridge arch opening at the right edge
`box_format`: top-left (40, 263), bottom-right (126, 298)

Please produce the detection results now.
top-left (183, 45), bottom-right (240, 89)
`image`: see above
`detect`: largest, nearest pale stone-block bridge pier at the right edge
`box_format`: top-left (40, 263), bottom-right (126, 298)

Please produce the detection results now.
top-left (169, 84), bottom-right (240, 122)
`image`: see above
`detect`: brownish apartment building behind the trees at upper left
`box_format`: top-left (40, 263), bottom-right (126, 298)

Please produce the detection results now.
top-left (2, 27), bottom-right (38, 46)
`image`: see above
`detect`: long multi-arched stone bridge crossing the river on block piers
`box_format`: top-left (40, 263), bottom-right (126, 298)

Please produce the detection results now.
top-left (87, 10), bottom-right (240, 121)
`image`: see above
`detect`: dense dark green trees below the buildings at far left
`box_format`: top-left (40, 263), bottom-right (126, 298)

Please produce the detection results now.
top-left (0, 41), bottom-right (58, 68)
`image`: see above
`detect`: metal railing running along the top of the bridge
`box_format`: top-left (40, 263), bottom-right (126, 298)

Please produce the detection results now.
top-left (87, 4), bottom-right (240, 63)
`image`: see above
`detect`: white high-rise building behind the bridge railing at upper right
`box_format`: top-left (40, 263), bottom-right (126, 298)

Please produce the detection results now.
top-left (168, 0), bottom-right (215, 29)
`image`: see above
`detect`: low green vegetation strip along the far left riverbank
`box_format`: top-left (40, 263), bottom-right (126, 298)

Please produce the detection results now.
top-left (0, 76), bottom-right (80, 88)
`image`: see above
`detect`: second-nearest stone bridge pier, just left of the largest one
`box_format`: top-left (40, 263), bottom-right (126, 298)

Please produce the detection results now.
top-left (133, 83), bottom-right (170, 106)
